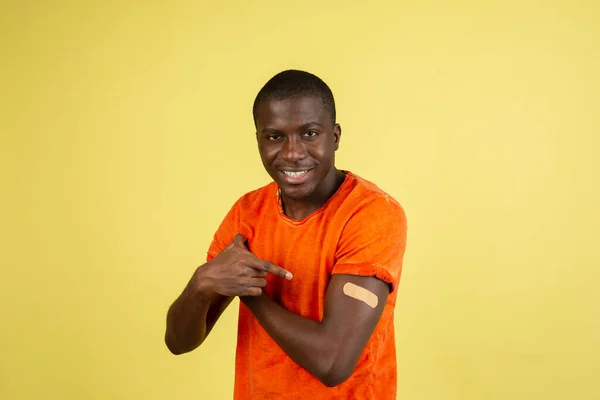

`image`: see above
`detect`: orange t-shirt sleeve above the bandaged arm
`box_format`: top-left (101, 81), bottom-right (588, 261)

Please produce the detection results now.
top-left (332, 196), bottom-right (407, 292)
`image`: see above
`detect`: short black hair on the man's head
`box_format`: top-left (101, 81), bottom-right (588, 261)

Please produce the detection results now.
top-left (252, 69), bottom-right (335, 125)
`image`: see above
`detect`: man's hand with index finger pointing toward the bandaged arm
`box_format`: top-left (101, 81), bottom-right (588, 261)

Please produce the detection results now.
top-left (190, 234), bottom-right (292, 296)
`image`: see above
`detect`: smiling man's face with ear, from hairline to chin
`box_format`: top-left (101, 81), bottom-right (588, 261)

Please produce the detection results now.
top-left (256, 95), bottom-right (341, 200)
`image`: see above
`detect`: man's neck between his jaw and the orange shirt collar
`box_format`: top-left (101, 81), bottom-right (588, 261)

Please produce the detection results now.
top-left (281, 167), bottom-right (346, 220)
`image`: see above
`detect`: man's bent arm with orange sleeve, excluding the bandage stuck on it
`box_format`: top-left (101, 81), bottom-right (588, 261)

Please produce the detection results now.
top-left (241, 196), bottom-right (407, 386)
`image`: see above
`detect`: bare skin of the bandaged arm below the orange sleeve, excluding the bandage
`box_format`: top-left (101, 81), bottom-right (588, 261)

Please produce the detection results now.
top-left (240, 275), bottom-right (390, 387)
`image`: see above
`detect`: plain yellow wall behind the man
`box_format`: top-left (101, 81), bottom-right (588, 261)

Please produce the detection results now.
top-left (0, 0), bottom-right (600, 400)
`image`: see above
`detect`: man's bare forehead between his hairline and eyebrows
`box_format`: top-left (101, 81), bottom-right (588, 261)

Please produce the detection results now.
top-left (256, 96), bottom-right (332, 128)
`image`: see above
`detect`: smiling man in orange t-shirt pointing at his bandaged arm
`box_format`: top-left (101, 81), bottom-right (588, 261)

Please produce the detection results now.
top-left (165, 70), bottom-right (406, 400)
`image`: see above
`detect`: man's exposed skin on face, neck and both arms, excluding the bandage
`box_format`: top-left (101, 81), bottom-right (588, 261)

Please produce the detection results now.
top-left (165, 96), bottom-right (390, 386)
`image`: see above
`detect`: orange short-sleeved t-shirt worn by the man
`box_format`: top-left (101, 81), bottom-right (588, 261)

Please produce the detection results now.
top-left (208, 171), bottom-right (406, 400)
